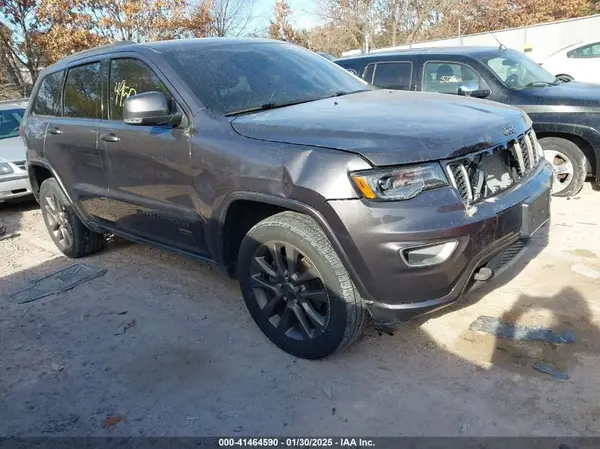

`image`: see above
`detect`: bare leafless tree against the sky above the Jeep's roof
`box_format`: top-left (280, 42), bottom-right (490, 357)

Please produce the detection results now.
top-left (210, 0), bottom-right (256, 37)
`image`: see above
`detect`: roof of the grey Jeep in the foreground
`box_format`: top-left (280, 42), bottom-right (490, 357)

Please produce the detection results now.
top-left (44, 37), bottom-right (284, 73)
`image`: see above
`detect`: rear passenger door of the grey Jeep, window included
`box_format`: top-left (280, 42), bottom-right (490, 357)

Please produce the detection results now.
top-left (44, 61), bottom-right (112, 221)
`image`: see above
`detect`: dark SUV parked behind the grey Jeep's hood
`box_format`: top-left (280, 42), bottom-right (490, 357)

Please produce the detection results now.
top-left (335, 47), bottom-right (600, 196)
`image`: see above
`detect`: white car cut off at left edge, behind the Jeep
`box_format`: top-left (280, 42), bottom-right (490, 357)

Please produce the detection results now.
top-left (0, 101), bottom-right (31, 203)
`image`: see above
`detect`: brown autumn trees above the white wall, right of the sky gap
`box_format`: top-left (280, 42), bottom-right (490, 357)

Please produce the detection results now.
top-left (269, 0), bottom-right (600, 56)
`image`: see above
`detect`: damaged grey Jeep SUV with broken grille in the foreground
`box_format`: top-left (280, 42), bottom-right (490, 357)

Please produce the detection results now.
top-left (22, 39), bottom-right (552, 358)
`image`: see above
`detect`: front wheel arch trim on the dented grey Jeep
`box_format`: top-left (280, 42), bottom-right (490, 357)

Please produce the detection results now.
top-left (215, 191), bottom-right (372, 302)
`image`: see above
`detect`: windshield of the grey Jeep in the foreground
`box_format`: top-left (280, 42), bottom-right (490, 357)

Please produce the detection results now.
top-left (164, 42), bottom-right (370, 114)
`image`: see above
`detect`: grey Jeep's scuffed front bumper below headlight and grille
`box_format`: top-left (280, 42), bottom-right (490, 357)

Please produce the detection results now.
top-left (323, 162), bottom-right (552, 330)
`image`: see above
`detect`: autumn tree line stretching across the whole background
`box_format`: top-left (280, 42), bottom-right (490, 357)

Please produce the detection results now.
top-left (0, 0), bottom-right (600, 96)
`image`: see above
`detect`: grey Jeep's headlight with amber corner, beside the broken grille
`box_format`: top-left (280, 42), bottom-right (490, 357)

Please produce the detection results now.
top-left (350, 163), bottom-right (448, 201)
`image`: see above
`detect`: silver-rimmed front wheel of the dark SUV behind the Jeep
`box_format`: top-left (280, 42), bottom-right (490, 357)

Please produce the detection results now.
top-left (540, 137), bottom-right (587, 197)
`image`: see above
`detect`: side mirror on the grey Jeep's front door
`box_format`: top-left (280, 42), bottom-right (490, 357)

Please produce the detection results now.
top-left (123, 92), bottom-right (182, 126)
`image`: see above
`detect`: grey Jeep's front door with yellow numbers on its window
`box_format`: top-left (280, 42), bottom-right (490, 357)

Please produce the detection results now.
top-left (98, 58), bottom-right (206, 255)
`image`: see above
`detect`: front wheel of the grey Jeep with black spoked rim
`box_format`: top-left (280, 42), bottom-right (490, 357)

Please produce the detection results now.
top-left (238, 212), bottom-right (368, 359)
